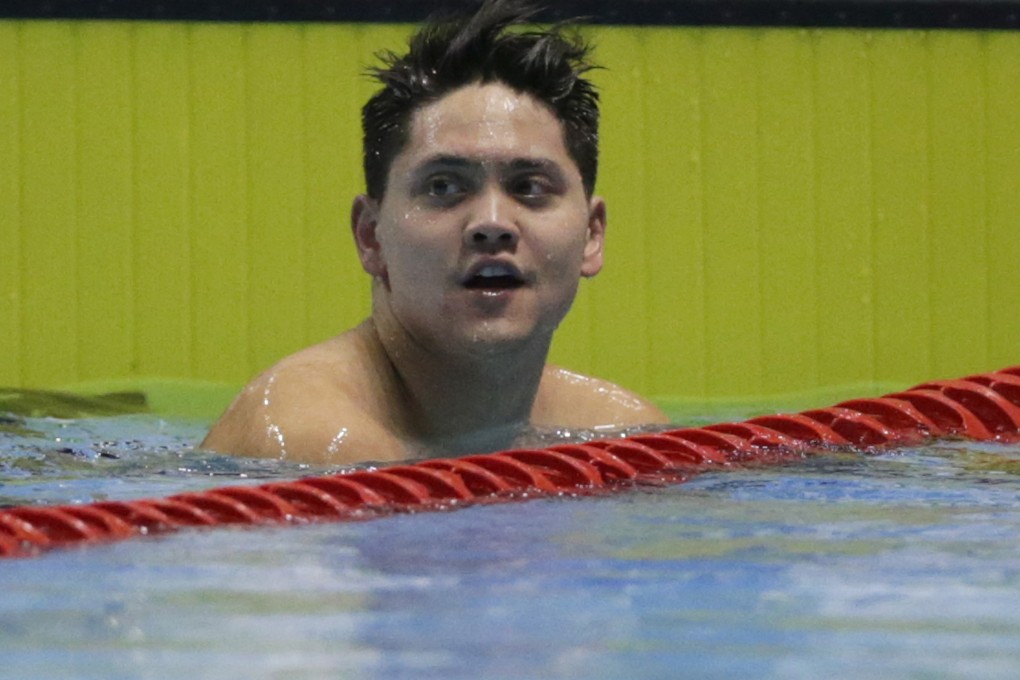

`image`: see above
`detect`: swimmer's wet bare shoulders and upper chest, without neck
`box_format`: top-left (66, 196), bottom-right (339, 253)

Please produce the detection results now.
top-left (202, 322), bottom-right (665, 463)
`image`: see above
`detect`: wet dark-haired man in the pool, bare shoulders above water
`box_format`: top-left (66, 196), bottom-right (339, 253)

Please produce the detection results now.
top-left (202, 0), bottom-right (665, 463)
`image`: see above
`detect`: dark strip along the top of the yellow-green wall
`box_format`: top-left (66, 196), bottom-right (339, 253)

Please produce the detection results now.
top-left (0, 0), bottom-right (1020, 30)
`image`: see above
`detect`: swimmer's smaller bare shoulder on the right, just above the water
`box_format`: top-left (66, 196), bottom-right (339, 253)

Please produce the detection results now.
top-left (531, 366), bottom-right (669, 427)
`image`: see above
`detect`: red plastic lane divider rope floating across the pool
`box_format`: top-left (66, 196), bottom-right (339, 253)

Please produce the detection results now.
top-left (0, 366), bottom-right (1020, 558)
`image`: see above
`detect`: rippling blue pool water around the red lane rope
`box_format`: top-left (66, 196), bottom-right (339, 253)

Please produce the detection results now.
top-left (0, 407), bottom-right (1020, 680)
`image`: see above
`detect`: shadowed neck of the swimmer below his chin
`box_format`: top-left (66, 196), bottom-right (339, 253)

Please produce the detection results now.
top-left (365, 314), bottom-right (551, 455)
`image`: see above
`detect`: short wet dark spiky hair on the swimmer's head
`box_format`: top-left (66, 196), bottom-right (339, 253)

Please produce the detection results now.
top-left (361, 0), bottom-right (599, 200)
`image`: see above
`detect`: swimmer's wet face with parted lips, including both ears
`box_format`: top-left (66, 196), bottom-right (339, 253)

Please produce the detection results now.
top-left (352, 84), bottom-right (606, 358)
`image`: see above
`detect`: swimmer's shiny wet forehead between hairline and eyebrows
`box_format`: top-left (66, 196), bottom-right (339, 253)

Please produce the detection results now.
top-left (400, 84), bottom-right (573, 166)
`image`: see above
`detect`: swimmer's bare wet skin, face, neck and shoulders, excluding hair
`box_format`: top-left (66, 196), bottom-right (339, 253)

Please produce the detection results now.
top-left (203, 84), bottom-right (664, 463)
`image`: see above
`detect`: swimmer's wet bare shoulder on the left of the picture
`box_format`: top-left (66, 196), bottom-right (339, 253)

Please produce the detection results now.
top-left (201, 336), bottom-right (404, 464)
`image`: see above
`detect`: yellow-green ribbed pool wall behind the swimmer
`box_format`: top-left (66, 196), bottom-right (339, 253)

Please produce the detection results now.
top-left (0, 21), bottom-right (1020, 411)
